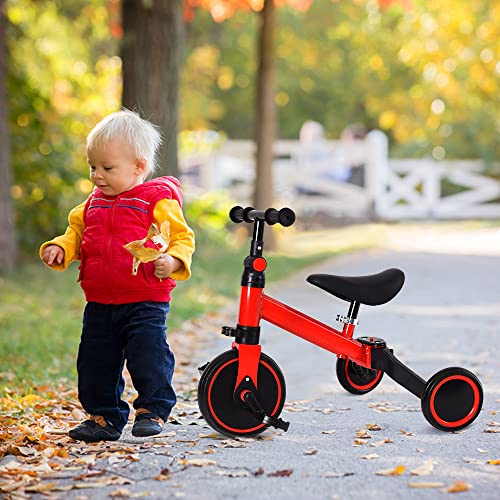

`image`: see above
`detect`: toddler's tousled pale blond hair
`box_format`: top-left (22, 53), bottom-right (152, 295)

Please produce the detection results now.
top-left (87, 108), bottom-right (162, 177)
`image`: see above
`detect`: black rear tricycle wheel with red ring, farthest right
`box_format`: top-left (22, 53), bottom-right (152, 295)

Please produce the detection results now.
top-left (421, 367), bottom-right (483, 432)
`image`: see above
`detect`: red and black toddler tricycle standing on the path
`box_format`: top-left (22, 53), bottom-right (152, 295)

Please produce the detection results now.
top-left (198, 207), bottom-right (483, 436)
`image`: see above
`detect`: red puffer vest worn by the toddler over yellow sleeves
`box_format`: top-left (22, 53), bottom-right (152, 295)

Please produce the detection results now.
top-left (79, 177), bottom-right (182, 304)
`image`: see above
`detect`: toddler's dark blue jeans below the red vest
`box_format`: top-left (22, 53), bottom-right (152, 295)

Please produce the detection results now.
top-left (77, 302), bottom-right (176, 432)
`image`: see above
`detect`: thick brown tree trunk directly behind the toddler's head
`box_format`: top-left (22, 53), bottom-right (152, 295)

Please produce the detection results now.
top-left (121, 0), bottom-right (184, 176)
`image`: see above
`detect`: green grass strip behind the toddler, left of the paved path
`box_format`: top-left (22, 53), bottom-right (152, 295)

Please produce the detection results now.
top-left (0, 234), bottom-right (338, 396)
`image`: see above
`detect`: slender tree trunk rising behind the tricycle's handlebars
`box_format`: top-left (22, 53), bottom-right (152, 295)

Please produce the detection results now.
top-left (254, 0), bottom-right (277, 250)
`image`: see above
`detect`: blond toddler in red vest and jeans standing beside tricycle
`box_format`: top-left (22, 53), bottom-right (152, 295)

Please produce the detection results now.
top-left (40, 110), bottom-right (194, 442)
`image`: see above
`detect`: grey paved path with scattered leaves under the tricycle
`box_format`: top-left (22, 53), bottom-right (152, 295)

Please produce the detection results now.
top-left (16, 251), bottom-right (500, 500)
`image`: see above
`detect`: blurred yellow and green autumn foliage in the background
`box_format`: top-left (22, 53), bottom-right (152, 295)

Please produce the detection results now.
top-left (7, 0), bottom-right (500, 254)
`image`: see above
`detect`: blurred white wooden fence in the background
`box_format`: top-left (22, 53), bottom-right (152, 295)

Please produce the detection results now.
top-left (181, 131), bottom-right (500, 219)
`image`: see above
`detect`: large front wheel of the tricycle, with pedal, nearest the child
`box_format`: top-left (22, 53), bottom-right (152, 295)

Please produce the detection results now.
top-left (198, 349), bottom-right (286, 436)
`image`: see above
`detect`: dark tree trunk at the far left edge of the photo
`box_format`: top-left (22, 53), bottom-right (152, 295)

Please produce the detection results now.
top-left (0, 0), bottom-right (17, 273)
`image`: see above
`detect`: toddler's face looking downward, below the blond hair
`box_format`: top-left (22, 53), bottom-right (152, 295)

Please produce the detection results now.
top-left (87, 139), bottom-right (146, 196)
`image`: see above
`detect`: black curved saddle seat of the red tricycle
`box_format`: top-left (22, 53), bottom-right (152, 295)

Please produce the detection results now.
top-left (307, 268), bottom-right (405, 306)
